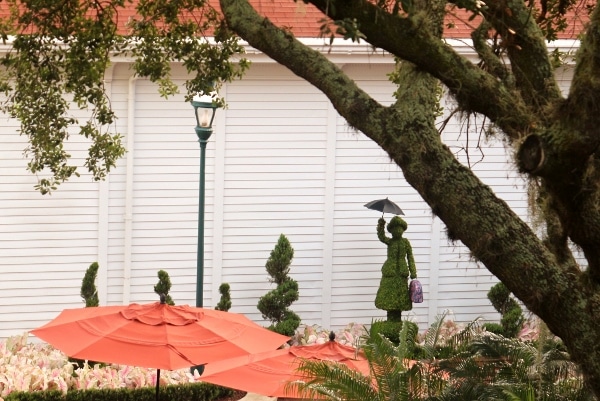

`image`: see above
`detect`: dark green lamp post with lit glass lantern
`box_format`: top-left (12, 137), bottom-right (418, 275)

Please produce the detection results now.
top-left (192, 95), bottom-right (218, 307)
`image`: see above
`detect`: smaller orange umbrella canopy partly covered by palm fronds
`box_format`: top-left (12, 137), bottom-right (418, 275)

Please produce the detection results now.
top-left (200, 334), bottom-right (369, 398)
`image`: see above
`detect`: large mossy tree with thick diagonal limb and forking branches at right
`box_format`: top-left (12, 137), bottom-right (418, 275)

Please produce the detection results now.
top-left (220, 0), bottom-right (600, 395)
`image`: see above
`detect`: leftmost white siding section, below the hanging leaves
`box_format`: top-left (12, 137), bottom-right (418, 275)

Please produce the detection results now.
top-left (0, 108), bottom-right (98, 337)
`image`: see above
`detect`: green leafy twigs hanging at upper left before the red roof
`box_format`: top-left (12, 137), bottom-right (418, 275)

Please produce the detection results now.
top-left (0, 0), bottom-right (248, 194)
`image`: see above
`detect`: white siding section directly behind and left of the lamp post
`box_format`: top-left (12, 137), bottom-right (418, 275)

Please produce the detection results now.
top-left (120, 72), bottom-right (205, 304)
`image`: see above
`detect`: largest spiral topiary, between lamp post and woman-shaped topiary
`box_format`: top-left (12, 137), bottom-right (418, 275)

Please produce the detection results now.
top-left (258, 234), bottom-right (300, 336)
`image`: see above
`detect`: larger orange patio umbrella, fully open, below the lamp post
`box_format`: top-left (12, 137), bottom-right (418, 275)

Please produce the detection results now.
top-left (32, 297), bottom-right (289, 398)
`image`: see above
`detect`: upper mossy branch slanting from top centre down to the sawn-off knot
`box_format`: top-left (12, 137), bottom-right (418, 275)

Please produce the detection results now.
top-left (309, 0), bottom-right (536, 139)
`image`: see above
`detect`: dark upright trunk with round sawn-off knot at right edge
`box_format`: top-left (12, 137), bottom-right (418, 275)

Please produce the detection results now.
top-left (518, 4), bottom-right (600, 282)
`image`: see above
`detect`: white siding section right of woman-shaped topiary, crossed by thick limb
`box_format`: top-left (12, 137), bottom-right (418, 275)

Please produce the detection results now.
top-left (428, 101), bottom-right (528, 321)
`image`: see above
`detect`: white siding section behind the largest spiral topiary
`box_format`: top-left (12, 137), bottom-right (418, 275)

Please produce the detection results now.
top-left (221, 65), bottom-right (328, 321)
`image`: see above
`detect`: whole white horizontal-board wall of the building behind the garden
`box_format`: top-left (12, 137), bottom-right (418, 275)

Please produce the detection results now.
top-left (0, 49), bottom-right (572, 337)
